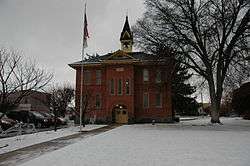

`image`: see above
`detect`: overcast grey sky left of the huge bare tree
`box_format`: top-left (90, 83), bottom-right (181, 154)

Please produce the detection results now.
top-left (0, 0), bottom-right (145, 84)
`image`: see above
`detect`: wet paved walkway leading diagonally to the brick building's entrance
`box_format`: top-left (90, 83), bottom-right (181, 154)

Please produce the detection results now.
top-left (0, 124), bottom-right (120, 166)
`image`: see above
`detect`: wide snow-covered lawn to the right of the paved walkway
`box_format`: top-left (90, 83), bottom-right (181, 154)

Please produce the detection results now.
top-left (21, 118), bottom-right (250, 166)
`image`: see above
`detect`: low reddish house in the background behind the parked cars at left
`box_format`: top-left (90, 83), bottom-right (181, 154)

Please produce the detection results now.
top-left (10, 91), bottom-right (50, 112)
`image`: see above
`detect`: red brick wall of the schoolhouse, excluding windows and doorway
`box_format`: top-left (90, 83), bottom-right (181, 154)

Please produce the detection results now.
top-left (73, 64), bottom-right (172, 123)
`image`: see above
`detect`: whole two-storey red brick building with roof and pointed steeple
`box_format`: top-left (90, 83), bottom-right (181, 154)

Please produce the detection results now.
top-left (70, 17), bottom-right (172, 123)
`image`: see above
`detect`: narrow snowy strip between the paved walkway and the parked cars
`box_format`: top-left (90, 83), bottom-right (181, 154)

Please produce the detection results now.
top-left (0, 125), bottom-right (106, 154)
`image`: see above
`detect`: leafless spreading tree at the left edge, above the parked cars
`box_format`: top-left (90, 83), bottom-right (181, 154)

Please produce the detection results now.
top-left (0, 48), bottom-right (53, 112)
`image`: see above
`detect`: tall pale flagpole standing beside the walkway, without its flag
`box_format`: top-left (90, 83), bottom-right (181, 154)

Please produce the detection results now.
top-left (80, 3), bottom-right (86, 132)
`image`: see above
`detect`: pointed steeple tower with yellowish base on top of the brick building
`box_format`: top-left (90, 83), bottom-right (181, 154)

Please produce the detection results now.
top-left (120, 16), bottom-right (133, 52)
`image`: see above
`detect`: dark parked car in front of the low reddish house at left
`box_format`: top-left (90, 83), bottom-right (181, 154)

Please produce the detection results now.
top-left (7, 111), bottom-right (50, 128)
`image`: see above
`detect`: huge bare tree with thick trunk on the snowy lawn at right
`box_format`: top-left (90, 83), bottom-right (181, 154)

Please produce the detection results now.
top-left (133, 0), bottom-right (250, 123)
